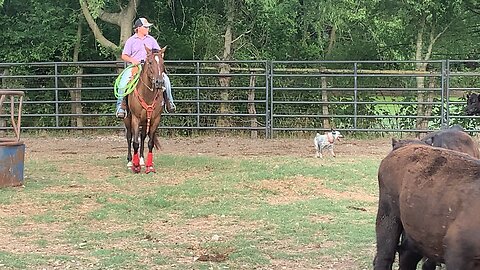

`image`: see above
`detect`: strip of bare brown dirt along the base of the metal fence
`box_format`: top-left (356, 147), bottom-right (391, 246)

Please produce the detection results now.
top-left (24, 135), bottom-right (391, 160)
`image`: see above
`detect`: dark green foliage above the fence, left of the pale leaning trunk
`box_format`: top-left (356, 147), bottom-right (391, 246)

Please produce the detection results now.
top-left (0, 0), bottom-right (79, 62)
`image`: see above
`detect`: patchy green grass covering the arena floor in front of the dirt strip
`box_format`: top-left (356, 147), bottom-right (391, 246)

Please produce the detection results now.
top-left (0, 148), bottom-right (379, 269)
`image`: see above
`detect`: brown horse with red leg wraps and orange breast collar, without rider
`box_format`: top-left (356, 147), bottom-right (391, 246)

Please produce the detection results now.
top-left (124, 47), bottom-right (166, 173)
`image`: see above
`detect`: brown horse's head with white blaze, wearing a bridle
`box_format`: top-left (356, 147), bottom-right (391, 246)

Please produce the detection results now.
top-left (143, 46), bottom-right (166, 91)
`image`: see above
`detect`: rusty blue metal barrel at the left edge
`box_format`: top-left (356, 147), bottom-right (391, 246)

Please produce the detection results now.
top-left (0, 141), bottom-right (25, 187)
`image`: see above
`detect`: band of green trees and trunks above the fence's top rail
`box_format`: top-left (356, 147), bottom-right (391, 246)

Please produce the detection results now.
top-left (0, 0), bottom-right (480, 62)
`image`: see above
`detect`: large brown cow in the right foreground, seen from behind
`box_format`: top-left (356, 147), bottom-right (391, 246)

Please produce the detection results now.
top-left (374, 144), bottom-right (480, 270)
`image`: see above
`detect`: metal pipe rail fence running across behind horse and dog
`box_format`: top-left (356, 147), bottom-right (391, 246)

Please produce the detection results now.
top-left (0, 60), bottom-right (480, 138)
